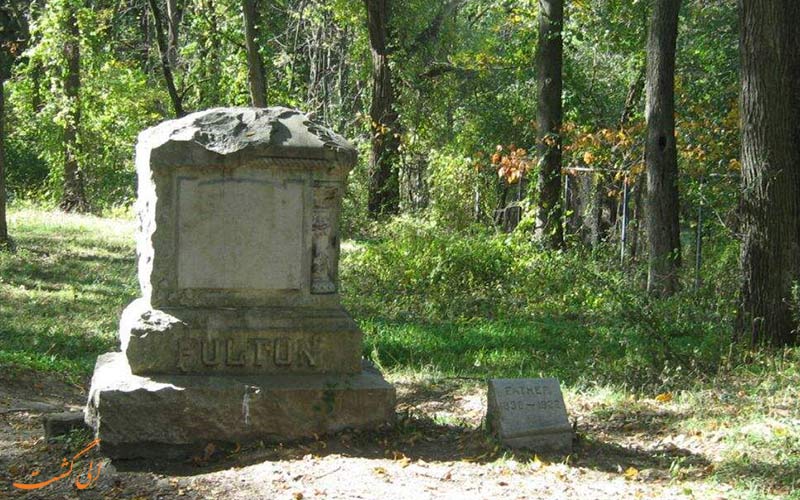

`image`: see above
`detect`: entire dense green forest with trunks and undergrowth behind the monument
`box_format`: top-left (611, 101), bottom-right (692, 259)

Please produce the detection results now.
top-left (3, 0), bottom-right (800, 367)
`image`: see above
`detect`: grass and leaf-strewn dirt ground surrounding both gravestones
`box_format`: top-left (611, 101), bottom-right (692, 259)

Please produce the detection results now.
top-left (0, 208), bottom-right (800, 498)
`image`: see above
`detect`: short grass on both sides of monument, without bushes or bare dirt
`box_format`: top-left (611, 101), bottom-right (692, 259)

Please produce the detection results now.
top-left (0, 208), bottom-right (800, 498)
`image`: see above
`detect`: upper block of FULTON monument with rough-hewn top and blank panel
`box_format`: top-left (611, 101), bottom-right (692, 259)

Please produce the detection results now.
top-left (136, 108), bottom-right (356, 309)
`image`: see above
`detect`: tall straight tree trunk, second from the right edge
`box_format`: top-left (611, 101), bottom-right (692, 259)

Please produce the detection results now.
top-left (645, 0), bottom-right (681, 295)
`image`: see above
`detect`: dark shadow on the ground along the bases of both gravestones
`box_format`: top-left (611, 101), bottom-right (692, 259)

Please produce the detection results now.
top-left (114, 379), bottom-right (710, 478)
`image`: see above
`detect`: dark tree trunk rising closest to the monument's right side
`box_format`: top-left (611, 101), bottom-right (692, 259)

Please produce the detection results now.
top-left (364, 0), bottom-right (400, 217)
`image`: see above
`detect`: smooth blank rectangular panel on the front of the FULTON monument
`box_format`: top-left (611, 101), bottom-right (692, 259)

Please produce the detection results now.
top-left (176, 168), bottom-right (304, 290)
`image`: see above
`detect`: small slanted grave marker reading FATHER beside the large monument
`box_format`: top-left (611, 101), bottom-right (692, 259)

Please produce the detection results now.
top-left (486, 378), bottom-right (573, 453)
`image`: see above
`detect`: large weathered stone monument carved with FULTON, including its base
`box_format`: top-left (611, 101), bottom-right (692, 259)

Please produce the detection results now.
top-left (85, 108), bottom-right (395, 457)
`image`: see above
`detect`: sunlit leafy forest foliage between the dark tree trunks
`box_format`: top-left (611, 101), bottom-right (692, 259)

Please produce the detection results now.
top-left (0, 0), bottom-right (739, 217)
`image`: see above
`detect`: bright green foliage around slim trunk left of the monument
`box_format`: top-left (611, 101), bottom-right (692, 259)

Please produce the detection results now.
top-left (8, 0), bottom-right (160, 208)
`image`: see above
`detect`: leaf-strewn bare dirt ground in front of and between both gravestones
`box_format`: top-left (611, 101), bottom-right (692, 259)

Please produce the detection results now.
top-left (0, 367), bottom-right (728, 500)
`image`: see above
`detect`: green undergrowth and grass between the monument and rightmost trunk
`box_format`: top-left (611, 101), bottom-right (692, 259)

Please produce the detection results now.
top-left (342, 219), bottom-right (736, 387)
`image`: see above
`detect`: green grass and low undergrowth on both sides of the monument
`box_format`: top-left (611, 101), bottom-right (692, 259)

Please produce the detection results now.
top-left (0, 208), bottom-right (800, 499)
